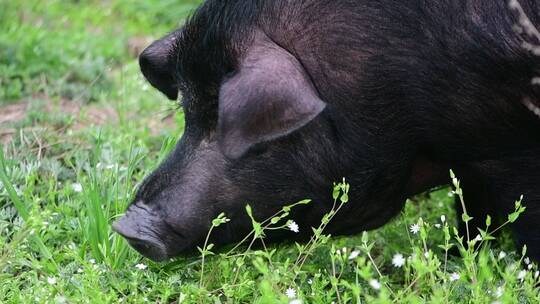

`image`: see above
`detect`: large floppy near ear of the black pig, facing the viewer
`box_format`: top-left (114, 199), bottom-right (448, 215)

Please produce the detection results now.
top-left (218, 44), bottom-right (326, 159)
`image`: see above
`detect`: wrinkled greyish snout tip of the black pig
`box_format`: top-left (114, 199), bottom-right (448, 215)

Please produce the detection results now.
top-left (112, 203), bottom-right (169, 261)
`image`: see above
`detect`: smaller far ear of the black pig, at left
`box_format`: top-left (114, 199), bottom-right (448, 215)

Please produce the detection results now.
top-left (139, 33), bottom-right (178, 100)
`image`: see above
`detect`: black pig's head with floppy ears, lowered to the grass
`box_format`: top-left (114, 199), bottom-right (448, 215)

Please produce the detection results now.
top-left (114, 8), bottom-right (410, 260)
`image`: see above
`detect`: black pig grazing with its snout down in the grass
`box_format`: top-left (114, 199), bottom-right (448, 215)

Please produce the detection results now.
top-left (114, 0), bottom-right (540, 260)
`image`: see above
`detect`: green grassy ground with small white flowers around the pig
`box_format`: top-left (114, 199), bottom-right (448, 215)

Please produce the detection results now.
top-left (0, 0), bottom-right (540, 303)
